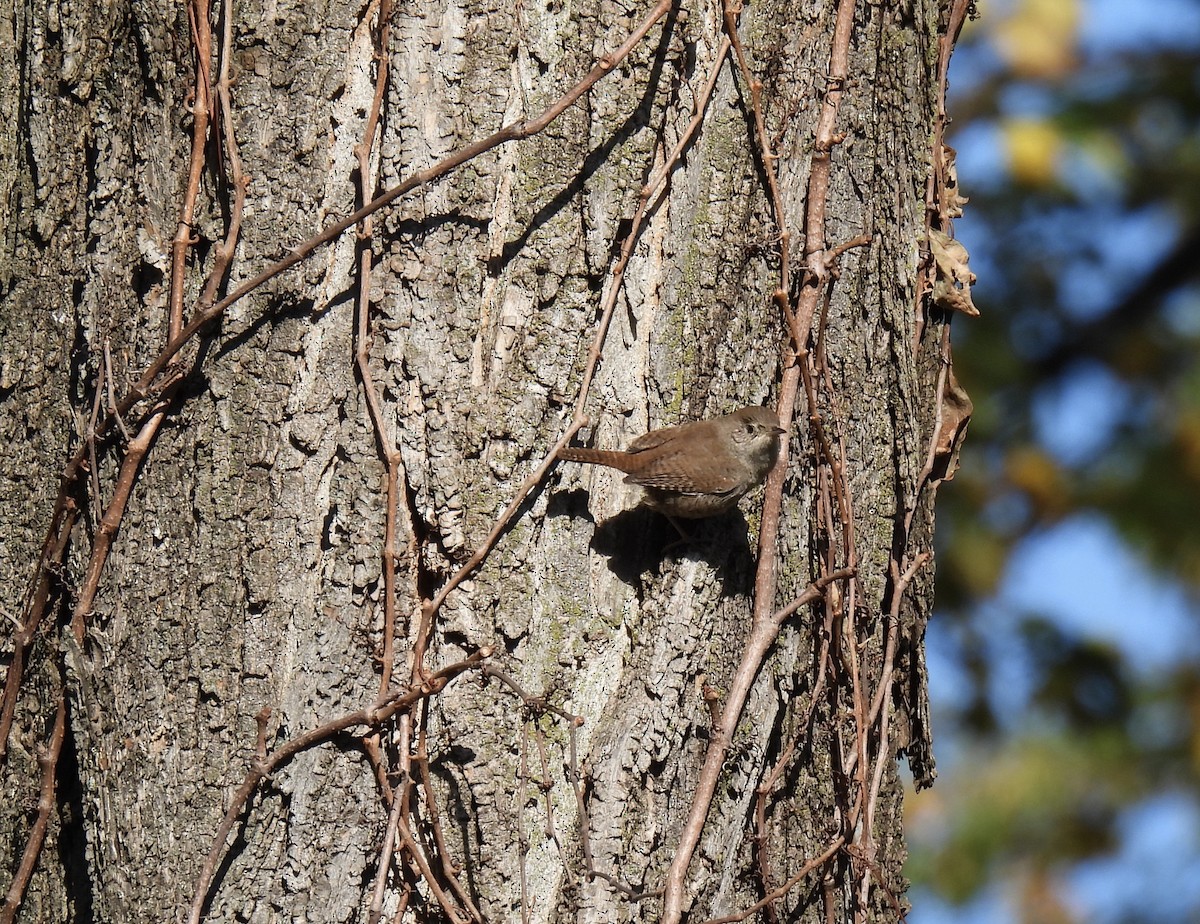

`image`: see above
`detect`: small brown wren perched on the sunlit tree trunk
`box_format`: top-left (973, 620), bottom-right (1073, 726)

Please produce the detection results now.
top-left (558, 407), bottom-right (784, 518)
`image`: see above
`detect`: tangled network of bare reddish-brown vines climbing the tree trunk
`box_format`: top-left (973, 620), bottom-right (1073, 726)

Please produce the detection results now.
top-left (0, 0), bottom-right (968, 924)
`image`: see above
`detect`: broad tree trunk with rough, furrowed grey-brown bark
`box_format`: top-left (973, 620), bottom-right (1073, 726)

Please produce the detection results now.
top-left (0, 0), bottom-right (968, 922)
